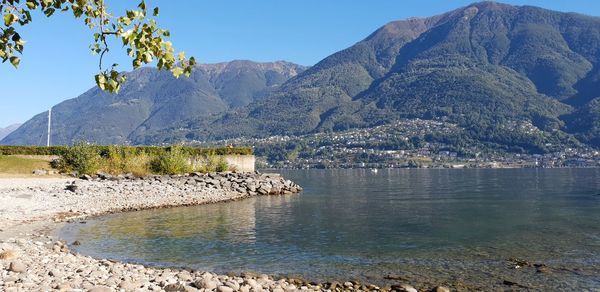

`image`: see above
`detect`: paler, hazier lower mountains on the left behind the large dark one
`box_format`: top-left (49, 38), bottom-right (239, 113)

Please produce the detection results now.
top-left (2, 61), bottom-right (306, 145)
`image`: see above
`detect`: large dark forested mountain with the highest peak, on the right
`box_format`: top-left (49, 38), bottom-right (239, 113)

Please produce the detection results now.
top-left (135, 2), bottom-right (600, 148)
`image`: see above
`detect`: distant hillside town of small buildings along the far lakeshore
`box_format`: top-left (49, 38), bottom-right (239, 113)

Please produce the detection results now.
top-left (191, 119), bottom-right (600, 169)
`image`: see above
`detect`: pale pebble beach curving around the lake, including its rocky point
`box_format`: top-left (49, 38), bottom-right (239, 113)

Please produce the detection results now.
top-left (0, 173), bottom-right (449, 292)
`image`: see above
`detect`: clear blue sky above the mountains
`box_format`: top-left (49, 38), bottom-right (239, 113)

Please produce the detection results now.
top-left (0, 0), bottom-right (600, 128)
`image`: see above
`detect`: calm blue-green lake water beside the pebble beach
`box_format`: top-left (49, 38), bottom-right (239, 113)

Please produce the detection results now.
top-left (62, 169), bottom-right (600, 290)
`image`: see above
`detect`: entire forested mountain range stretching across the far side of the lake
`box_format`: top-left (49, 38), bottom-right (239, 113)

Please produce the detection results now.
top-left (2, 2), bottom-right (600, 151)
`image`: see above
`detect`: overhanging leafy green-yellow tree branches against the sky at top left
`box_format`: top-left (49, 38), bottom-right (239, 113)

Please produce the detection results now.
top-left (0, 0), bottom-right (195, 92)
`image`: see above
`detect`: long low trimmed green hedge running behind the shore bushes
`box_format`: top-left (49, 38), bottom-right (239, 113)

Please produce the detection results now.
top-left (0, 145), bottom-right (252, 156)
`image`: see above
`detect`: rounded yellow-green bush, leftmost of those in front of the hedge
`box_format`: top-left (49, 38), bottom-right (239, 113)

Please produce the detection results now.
top-left (57, 143), bottom-right (100, 175)
